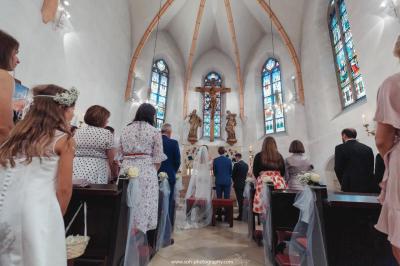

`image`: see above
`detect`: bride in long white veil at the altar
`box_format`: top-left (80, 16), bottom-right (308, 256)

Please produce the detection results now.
top-left (176, 146), bottom-right (212, 229)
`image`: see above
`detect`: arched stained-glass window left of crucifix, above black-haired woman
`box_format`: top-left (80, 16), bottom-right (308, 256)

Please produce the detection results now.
top-left (150, 59), bottom-right (169, 128)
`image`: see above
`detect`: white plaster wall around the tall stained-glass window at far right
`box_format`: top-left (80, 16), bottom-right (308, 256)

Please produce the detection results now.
top-left (301, 0), bottom-right (400, 188)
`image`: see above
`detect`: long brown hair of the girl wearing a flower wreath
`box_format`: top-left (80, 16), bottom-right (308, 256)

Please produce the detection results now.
top-left (0, 85), bottom-right (73, 167)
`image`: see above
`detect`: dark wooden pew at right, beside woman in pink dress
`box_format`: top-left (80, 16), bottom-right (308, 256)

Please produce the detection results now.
top-left (324, 192), bottom-right (397, 266)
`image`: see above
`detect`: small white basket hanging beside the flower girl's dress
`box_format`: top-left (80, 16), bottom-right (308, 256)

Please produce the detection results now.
top-left (65, 202), bottom-right (90, 259)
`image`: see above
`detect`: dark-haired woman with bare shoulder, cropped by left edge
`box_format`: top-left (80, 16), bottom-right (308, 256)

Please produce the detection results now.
top-left (0, 30), bottom-right (19, 144)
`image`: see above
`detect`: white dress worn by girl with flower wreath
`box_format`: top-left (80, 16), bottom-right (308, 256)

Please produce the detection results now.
top-left (0, 132), bottom-right (67, 266)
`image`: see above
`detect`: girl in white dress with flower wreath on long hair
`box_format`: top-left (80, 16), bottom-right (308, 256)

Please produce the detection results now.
top-left (0, 85), bottom-right (78, 266)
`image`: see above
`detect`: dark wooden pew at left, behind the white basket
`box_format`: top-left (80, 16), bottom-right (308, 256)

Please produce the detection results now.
top-left (64, 182), bottom-right (128, 266)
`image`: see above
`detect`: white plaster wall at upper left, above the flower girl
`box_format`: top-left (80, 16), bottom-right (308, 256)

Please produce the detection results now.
top-left (0, 0), bottom-right (131, 128)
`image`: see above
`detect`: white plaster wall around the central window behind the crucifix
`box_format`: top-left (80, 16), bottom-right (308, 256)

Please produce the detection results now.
top-left (188, 49), bottom-right (242, 145)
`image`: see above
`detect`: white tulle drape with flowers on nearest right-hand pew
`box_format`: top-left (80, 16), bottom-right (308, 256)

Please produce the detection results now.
top-left (288, 186), bottom-right (328, 266)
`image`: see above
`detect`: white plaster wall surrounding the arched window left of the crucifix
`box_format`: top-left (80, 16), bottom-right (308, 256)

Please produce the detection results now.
top-left (124, 31), bottom-right (185, 140)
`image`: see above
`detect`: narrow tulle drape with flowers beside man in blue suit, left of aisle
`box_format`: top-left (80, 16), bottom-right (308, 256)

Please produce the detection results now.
top-left (156, 175), bottom-right (172, 251)
